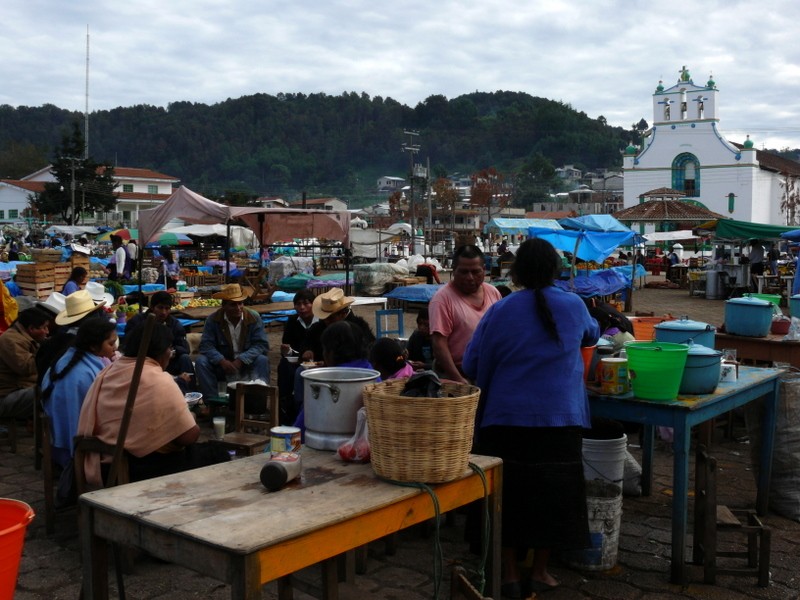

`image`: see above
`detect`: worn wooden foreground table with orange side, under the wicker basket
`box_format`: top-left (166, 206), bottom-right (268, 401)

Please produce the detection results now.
top-left (80, 447), bottom-right (502, 600)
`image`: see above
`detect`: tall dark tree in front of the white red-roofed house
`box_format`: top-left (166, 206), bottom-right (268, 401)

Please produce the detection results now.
top-left (29, 121), bottom-right (117, 225)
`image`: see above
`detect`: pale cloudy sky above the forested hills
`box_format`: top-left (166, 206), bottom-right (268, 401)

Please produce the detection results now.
top-left (6, 0), bottom-right (800, 148)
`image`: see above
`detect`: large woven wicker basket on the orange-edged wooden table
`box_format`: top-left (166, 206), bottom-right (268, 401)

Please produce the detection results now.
top-left (364, 379), bottom-right (480, 483)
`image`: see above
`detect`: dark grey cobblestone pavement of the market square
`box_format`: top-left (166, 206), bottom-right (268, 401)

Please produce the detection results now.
top-left (0, 278), bottom-right (800, 600)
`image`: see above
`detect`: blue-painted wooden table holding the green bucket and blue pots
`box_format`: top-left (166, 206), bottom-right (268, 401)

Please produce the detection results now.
top-left (589, 367), bottom-right (783, 584)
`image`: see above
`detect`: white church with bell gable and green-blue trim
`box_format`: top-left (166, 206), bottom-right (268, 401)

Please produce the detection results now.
top-left (623, 67), bottom-right (800, 225)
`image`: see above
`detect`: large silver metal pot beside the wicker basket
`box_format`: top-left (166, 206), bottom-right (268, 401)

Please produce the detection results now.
top-left (300, 367), bottom-right (380, 450)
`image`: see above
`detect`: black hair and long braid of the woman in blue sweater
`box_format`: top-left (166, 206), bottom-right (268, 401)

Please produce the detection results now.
top-left (510, 238), bottom-right (561, 345)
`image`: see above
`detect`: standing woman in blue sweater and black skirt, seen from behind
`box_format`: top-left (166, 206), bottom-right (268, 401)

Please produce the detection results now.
top-left (463, 239), bottom-right (600, 598)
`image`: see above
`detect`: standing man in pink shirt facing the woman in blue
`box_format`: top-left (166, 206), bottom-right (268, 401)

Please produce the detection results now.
top-left (428, 245), bottom-right (501, 383)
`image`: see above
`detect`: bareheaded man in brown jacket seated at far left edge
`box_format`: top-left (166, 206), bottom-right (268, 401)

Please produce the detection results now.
top-left (0, 306), bottom-right (50, 419)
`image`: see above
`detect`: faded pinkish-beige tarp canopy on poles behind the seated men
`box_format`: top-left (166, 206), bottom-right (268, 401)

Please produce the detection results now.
top-left (139, 186), bottom-right (350, 246)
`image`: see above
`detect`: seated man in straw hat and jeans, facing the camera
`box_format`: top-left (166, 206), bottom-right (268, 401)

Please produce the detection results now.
top-left (195, 283), bottom-right (270, 398)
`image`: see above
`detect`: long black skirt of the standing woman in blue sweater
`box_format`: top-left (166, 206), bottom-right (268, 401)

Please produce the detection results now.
top-left (477, 426), bottom-right (590, 550)
